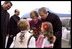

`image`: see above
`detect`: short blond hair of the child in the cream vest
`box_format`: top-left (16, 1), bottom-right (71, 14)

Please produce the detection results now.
top-left (18, 19), bottom-right (30, 30)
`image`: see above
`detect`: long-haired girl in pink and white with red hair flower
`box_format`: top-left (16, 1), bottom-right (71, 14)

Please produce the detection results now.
top-left (36, 22), bottom-right (56, 48)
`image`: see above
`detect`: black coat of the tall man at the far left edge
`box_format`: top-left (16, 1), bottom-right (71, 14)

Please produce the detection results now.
top-left (0, 7), bottom-right (10, 47)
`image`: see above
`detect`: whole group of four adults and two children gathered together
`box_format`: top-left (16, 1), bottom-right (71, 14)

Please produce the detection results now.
top-left (0, 1), bottom-right (62, 48)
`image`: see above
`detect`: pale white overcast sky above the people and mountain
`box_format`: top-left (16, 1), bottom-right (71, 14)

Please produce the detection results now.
top-left (1, 1), bottom-right (71, 17)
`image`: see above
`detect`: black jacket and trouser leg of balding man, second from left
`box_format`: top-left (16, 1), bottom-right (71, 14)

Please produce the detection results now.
top-left (7, 15), bottom-right (20, 48)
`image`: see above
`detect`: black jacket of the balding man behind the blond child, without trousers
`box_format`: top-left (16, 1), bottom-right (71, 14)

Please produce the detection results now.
top-left (9, 15), bottom-right (20, 36)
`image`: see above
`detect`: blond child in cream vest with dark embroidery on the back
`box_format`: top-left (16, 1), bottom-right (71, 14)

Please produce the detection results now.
top-left (10, 20), bottom-right (35, 48)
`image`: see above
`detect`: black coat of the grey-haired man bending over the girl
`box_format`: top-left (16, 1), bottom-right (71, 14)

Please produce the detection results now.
top-left (42, 11), bottom-right (62, 48)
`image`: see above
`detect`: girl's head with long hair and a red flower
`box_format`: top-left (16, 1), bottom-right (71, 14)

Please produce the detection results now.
top-left (42, 22), bottom-right (53, 37)
